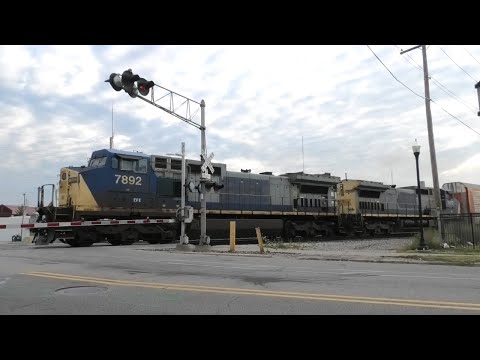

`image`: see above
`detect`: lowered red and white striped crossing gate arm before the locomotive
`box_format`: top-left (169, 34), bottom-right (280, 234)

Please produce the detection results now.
top-left (0, 219), bottom-right (176, 229)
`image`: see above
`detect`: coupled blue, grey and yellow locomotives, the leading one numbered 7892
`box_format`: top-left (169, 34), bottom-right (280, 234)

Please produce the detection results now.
top-left (31, 149), bottom-right (458, 246)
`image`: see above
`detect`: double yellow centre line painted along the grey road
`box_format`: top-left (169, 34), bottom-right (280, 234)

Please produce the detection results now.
top-left (23, 271), bottom-right (480, 311)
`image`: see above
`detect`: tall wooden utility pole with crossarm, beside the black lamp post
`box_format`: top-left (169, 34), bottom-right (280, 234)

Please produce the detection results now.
top-left (400, 45), bottom-right (442, 237)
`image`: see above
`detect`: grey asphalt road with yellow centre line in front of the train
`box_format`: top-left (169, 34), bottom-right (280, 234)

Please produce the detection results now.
top-left (0, 243), bottom-right (480, 315)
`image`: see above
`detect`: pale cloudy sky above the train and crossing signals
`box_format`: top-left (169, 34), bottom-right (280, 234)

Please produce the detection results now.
top-left (0, 45), bottom-right (480, 206)
